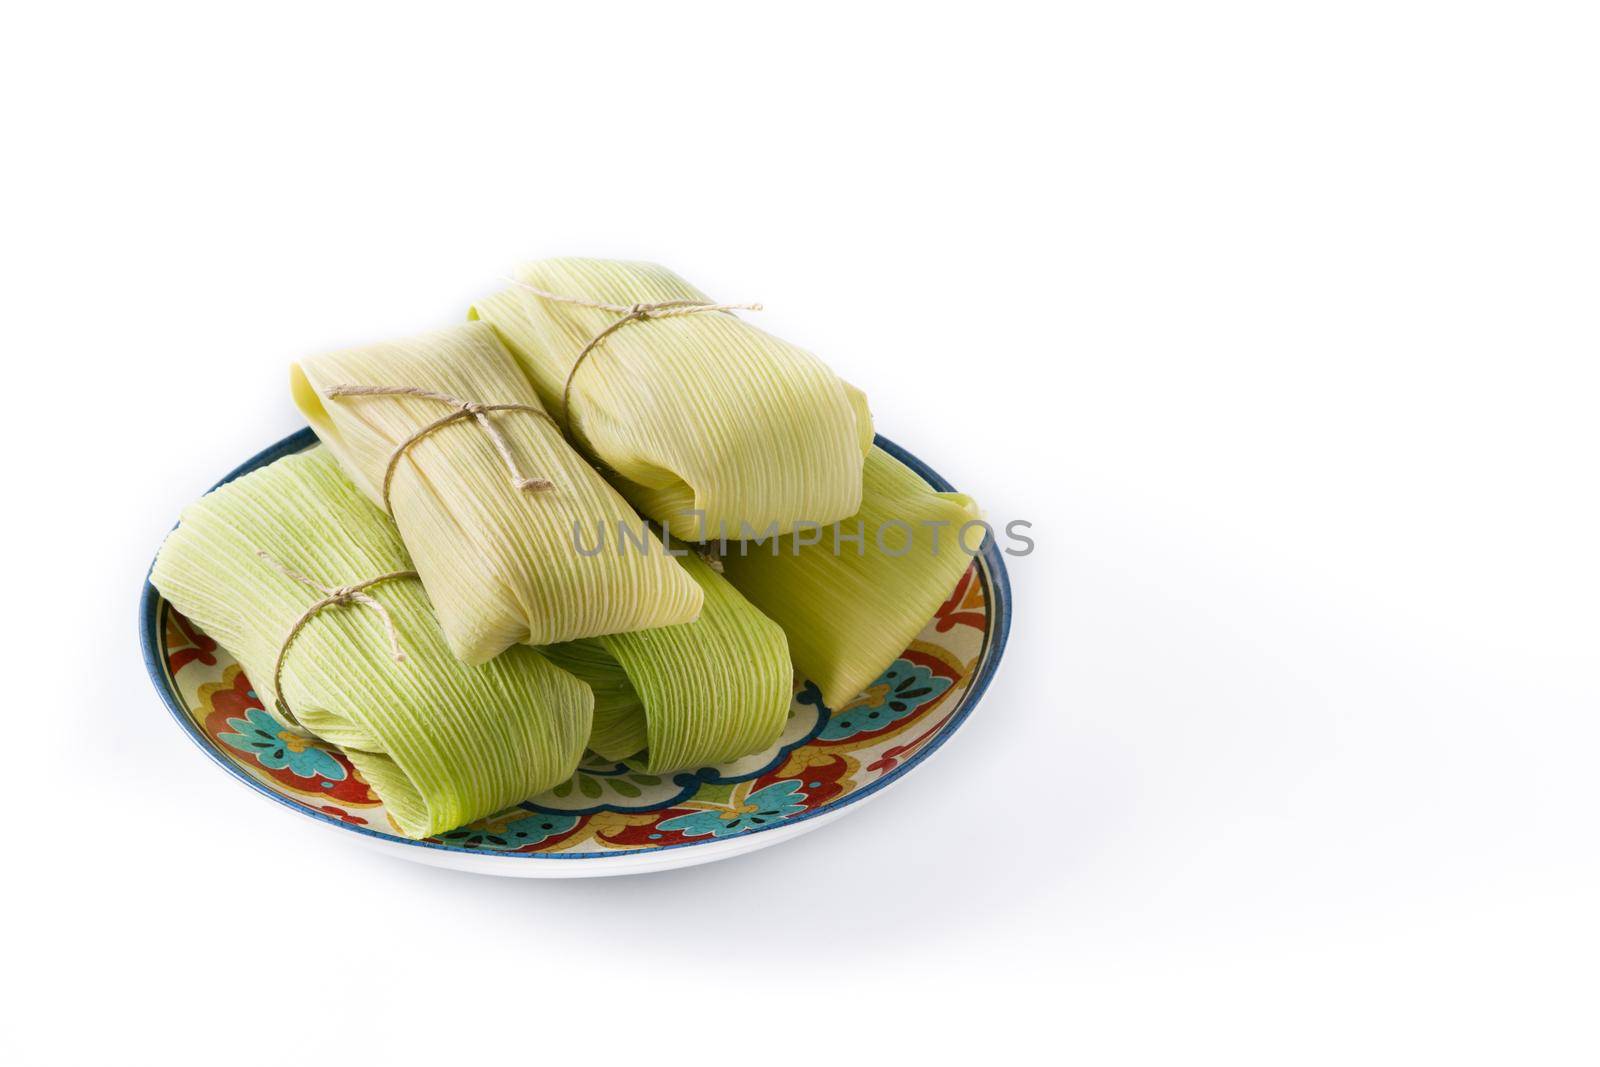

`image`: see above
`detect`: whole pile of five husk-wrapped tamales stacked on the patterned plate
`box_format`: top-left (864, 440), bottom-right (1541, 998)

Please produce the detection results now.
top-left (152, 259), bottom-right (976, 838)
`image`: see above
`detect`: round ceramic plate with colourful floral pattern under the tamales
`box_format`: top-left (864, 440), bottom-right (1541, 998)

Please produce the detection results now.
top-left (139, 429), bottom-right (1011, 878)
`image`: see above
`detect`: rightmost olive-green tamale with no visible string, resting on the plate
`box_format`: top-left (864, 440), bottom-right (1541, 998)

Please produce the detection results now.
top-left (723, 448), bottom-right (979, 707)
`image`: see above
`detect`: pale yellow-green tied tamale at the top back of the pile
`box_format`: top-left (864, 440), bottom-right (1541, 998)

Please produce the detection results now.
top-left (469, 259), bottom-right (872, 541)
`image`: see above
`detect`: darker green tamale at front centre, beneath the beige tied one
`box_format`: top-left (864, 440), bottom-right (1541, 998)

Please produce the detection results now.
top-left (542, 557), bottom-right (794, 773)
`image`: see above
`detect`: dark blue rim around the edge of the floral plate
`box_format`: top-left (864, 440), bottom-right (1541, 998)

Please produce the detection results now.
top-left (139, 427), bottom-right (1011, 859)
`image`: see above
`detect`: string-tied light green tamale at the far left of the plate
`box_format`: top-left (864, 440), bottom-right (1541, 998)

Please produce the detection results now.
top-left (150, 448), bottom-right (594, 838)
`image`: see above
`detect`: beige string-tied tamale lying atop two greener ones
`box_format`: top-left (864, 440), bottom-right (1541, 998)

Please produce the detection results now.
top-left (291, 323), bottom-right (701, 664)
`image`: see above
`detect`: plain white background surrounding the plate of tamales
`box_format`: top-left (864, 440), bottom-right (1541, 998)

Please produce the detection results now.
top-left (0, 2), bottom-right (1600, 1064)
